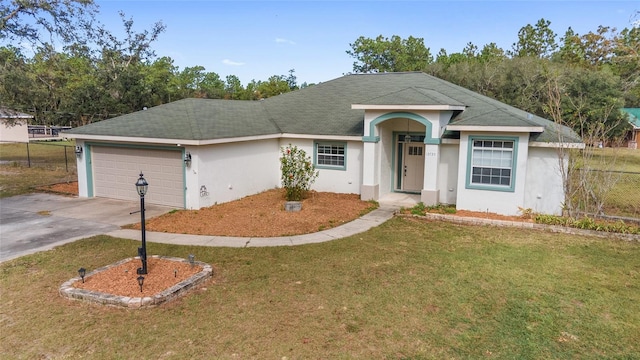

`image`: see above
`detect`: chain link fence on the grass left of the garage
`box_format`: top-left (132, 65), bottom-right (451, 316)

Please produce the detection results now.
top-left (0, 141), bottom-right (76, 173)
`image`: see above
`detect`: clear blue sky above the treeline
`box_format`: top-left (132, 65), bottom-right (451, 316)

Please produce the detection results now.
top-left (96, 0), bottom-right (640, 85)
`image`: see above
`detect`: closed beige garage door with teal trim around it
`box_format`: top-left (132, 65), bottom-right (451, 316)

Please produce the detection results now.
top-left (91, 146), bottom-right (184, 208)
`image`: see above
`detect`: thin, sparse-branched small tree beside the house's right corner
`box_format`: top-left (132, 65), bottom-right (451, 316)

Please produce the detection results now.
top-left (545, 67), bottom-right (624, 217)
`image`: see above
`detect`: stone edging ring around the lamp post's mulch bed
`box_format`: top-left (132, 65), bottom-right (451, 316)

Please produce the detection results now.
top-left (59, 255), bottom-right (213, 308)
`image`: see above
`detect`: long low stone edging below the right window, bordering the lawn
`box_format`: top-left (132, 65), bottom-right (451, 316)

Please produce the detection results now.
top-left (396, 212), bottom-right (640, 242)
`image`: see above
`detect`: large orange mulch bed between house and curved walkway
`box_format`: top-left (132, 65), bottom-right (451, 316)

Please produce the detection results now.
top-left (132, 189), bottom-right (375, 237)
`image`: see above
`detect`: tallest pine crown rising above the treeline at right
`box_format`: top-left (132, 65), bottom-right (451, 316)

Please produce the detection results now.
top-left (512, 18), bottom-right (557, 58)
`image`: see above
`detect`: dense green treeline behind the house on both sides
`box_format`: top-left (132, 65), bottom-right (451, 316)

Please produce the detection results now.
top-left (0, 0), bottom-right (640, 138)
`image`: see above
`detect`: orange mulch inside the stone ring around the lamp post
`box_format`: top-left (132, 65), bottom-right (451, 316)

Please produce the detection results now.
top-left (73, 257), bottom-right (202, 297)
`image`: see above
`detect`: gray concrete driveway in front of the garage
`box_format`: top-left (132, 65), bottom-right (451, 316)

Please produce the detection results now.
top-left (0, 193), bottom-right (173, 262)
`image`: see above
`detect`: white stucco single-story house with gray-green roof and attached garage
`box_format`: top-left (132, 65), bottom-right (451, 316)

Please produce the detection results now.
top-left (64, 72), bottom-right (584, 215)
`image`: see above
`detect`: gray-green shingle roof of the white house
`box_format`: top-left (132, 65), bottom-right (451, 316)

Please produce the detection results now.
top-left (67, 72), bottom-right (580, 142)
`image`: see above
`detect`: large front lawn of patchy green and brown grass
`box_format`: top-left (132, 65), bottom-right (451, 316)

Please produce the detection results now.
top-left (0, 218), bottom-right (640, 359)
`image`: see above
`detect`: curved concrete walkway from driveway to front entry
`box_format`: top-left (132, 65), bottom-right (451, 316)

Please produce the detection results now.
top-left (106, 204), bottom-right (400, 247)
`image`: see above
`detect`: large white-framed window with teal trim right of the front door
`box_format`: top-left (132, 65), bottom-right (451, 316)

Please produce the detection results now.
top-left (469, 139), bottom-right (515, 189)
